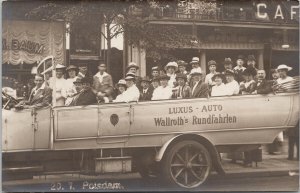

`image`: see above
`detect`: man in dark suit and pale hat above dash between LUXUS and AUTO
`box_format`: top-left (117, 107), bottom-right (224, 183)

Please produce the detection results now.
top-left (190, 69), bottom-right (209, 98)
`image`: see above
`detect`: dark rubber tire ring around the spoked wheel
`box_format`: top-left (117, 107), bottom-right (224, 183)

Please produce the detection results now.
top-left (160, 140), bottom-right (212, 190)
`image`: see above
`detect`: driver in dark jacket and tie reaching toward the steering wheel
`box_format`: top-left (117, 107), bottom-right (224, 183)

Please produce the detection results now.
top-left (15, 74), bottom-right (52, 109)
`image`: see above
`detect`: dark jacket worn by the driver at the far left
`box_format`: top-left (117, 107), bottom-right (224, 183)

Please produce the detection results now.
top-left (26, 86), bottom-right (52, 108)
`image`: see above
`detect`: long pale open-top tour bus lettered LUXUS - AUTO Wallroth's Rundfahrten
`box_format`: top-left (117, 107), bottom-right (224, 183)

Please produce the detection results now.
top-left (2, 56), bottom-right (299, 188)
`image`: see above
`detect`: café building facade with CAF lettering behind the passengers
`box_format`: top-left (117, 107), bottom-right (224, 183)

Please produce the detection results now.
top-left (127, 0), bottom-right (299, 75)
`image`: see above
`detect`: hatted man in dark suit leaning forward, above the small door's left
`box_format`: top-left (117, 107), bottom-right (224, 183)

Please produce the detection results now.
top-left (69, 77), bottom-right (97, 106)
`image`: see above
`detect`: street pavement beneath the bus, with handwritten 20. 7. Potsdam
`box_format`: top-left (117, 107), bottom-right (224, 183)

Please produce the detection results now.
top-left (2, 139), bottom-right (299, 192)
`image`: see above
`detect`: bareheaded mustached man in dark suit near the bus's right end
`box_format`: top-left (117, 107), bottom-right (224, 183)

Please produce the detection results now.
top-left (252, 70), bottom-right (273, 94)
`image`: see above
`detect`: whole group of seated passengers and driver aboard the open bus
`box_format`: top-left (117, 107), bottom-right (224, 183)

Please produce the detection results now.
top-left (17, 55), bottom-right (292, 107)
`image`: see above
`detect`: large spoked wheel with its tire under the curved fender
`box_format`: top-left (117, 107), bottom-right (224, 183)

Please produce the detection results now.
top-left (162, 141), bottom-right (211, 188)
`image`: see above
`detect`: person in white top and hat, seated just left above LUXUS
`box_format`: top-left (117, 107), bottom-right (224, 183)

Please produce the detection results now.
top-left (151, 75), bottom-right (173, 100)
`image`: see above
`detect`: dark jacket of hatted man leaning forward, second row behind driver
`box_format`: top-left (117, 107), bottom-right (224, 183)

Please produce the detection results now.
top-left (70, 89), bottom-right (97, 106)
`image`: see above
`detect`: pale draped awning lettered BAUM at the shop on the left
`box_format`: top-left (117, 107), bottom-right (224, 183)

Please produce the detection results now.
top-left (2, 20), bottom-right (65, 65)
